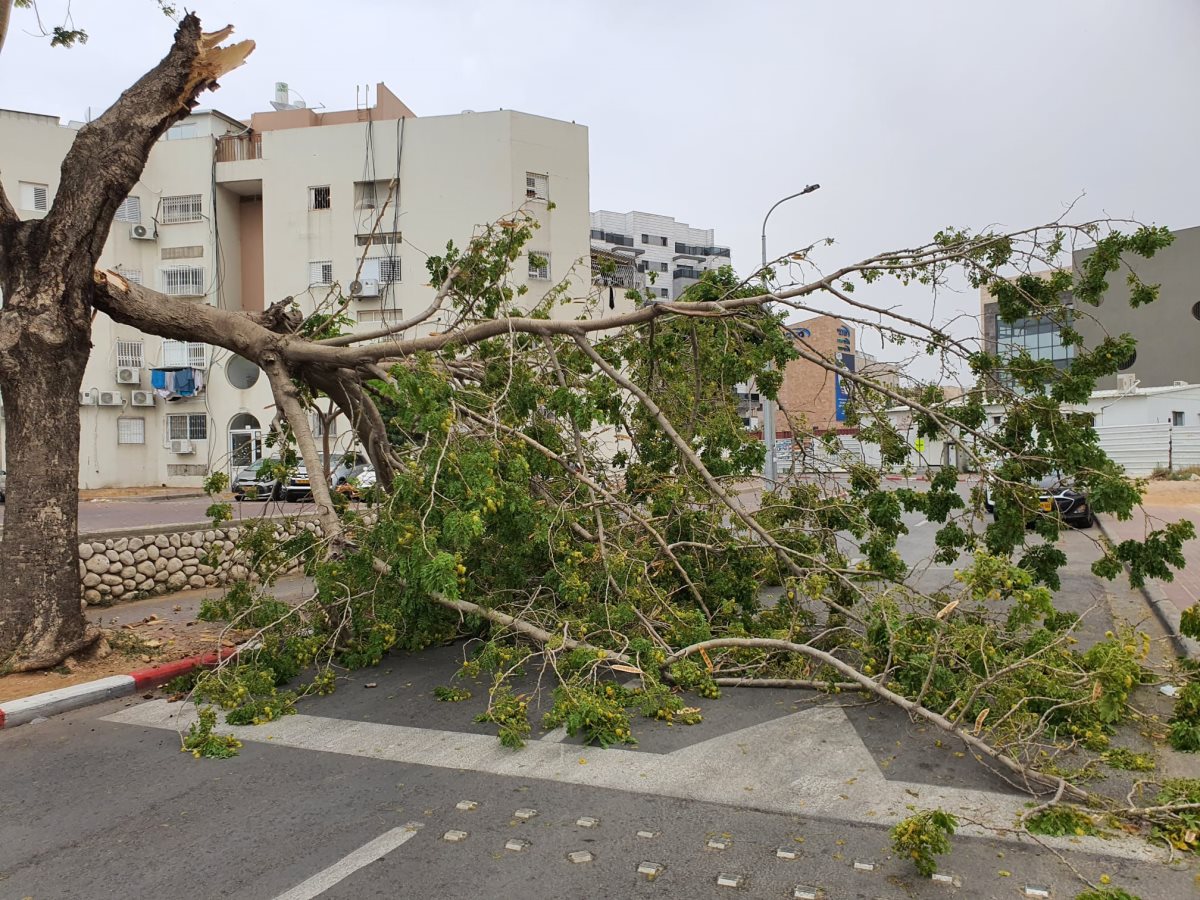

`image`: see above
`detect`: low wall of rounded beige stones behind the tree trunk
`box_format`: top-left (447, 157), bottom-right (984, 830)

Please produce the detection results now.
top-left (79, 518), bottom-right (322, 606)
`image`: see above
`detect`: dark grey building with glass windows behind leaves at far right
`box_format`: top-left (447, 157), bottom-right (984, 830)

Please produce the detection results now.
top-left (980, 227), bottom-right (1200, 390)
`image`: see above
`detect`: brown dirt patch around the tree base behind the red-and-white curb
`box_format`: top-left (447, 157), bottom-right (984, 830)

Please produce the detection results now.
top-left (0, 617), bottom-right (245, 702)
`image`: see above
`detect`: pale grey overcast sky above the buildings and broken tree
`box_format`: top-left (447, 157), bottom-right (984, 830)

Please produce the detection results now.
top-left (0, 0), bottom-right (1200, 372)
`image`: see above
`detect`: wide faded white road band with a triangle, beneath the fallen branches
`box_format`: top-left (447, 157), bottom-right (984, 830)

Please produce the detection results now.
top-left (103, 700), bottom-right (1157, 860)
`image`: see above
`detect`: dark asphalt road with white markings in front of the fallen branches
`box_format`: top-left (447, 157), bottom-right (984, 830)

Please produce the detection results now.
top-left (0, 482), bottom-right (1195, 900)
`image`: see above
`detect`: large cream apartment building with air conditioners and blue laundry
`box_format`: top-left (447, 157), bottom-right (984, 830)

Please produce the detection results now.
top-left (0, 84), bottom-right (604, 487)
